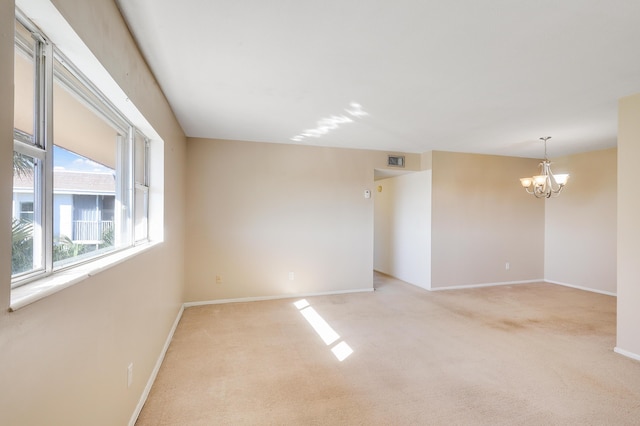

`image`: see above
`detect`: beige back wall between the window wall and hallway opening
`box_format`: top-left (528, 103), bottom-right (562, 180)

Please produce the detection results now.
top-left (186, 138), bottom-right (420, 301)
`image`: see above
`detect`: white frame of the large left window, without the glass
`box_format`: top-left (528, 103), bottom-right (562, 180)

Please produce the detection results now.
top-left (11, 9), bottom-right (150, 289)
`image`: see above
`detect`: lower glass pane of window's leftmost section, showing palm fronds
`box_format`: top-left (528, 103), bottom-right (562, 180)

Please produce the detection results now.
top-left (11, 152), bottom-right (42, 276)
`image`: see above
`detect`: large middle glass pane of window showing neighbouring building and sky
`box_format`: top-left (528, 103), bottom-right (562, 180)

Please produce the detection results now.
top-left (53, 62), bottom-right (120, 267)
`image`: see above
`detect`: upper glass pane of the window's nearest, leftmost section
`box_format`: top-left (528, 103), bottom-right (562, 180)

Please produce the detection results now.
top-left (13, 22), bottom-right (35, 143)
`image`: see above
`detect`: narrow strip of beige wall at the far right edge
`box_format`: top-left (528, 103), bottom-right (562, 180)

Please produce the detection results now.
top-left (616, 94), bottom-right (640, 359)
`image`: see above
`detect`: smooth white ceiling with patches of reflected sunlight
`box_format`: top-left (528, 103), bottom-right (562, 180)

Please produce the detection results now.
top-left (118, 0), bottom-right (640, 158)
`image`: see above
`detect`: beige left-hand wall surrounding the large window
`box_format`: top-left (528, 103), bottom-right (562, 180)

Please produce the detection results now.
top-left (0, 0), bottom-right (186, 425)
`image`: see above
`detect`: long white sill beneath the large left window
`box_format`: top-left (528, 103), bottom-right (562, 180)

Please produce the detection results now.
top-left (9, 242), bottom-right (159, 312)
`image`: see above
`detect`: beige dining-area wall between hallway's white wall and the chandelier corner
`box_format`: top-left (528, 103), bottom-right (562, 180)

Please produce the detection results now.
top-left (431, 151), bottom-right (544, 288)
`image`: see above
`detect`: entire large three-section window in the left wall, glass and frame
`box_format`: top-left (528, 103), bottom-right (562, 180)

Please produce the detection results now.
top-left (12, 11), bottom-right (149, 287)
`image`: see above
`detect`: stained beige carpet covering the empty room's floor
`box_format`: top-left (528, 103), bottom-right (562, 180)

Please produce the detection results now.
top-left (137, 275), bottom-right (640, 426)
